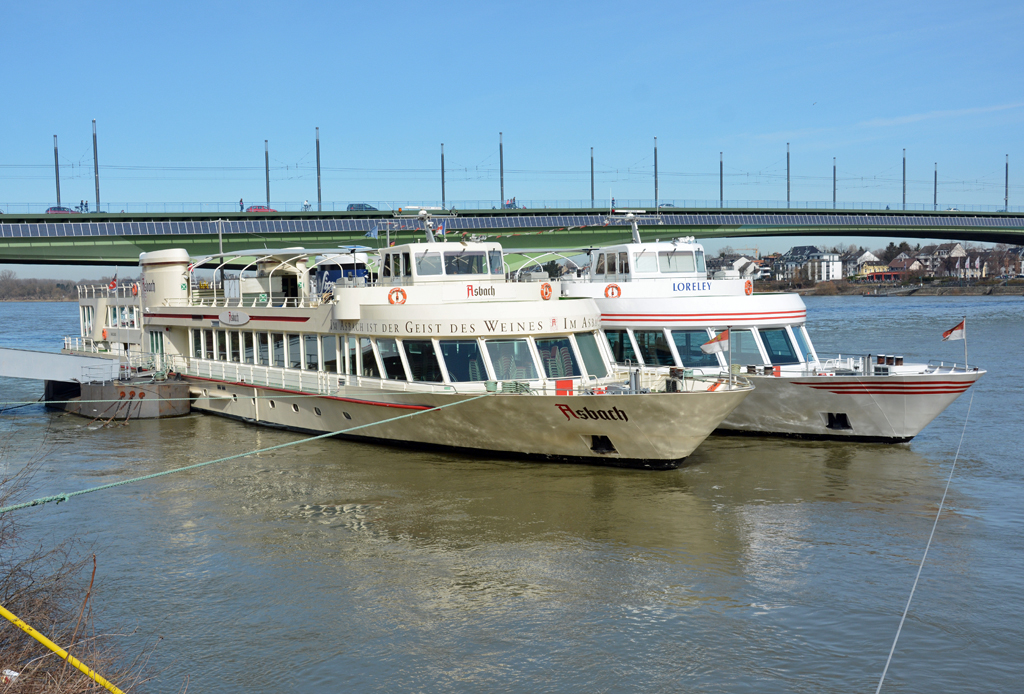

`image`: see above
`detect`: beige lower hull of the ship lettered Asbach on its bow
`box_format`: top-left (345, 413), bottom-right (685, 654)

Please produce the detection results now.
top-left (188, 377), bottom-right (751, 470)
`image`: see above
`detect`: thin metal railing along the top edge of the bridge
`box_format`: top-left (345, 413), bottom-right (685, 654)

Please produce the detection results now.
top-left (0, 198), bottom-right (1024, 217)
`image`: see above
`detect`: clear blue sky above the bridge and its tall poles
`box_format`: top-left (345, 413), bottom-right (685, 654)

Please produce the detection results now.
top-left (0, 2), bottom-right (1024, 274)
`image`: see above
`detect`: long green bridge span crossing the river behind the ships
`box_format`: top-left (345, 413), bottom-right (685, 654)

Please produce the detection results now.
top-left (0, 208), bottom-right (1024, 265)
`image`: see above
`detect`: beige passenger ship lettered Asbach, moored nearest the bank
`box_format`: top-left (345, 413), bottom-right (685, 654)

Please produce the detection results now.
top-left (66, 216), bottom-right (752, 469)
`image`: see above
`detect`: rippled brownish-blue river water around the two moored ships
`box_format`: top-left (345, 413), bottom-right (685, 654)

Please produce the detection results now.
top-left (0, 297), bottom-right (1024, 693)
